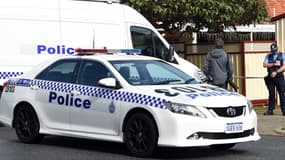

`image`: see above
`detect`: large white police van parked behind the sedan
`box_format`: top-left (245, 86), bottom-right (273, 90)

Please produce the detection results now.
top-left (0, 0), bottom-right (205, 93)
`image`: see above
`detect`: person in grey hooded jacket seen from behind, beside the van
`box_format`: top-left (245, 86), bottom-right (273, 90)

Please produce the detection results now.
top-left (203, 38), bottom-right (233, 89)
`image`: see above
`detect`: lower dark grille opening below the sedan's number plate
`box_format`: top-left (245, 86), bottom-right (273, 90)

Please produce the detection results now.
top-left (197, 128), bottom-right (254, 139)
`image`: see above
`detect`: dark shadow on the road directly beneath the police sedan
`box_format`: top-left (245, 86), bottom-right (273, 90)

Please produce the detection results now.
top-left (40, 136), bottom-right (247, 159)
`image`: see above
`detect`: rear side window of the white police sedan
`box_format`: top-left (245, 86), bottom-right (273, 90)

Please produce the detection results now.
top-left (36, 59), bottom-right (79, 83)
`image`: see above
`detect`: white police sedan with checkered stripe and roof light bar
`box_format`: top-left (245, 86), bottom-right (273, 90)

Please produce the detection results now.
top-left (0, 50), bottom-right (260, 157)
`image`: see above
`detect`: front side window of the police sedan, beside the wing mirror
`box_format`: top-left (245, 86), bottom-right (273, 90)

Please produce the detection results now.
top-left (78, 60), bottom-right (113, 86)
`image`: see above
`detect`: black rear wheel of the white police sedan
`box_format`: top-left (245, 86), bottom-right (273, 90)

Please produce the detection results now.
top-left (14, 106), bottom-right (43, 143)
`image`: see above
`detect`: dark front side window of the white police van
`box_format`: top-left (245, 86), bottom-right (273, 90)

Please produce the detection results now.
top-left (131, 26), bottom-right (169, 61)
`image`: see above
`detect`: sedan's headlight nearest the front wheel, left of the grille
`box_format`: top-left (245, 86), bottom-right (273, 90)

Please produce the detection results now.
top-left (164, 102), bottom-right (207, 118)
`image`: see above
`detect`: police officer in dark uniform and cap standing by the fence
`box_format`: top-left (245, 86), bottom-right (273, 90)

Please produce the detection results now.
top-left (263, 43), bottom-right (285, 116)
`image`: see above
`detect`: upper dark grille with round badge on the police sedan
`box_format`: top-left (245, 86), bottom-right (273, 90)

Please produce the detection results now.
top-left (208, 106), bottom-right (245, 117)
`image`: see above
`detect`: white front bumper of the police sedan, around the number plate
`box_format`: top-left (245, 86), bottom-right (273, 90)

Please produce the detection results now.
top-left (154, 111), bottom-right (260, 147)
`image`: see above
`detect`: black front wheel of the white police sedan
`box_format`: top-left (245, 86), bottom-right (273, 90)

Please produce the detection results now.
top-left (124, 113), bottom-right (158, 157)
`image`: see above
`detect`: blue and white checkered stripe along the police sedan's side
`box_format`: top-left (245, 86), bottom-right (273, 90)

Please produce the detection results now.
top-left (24, 79), bottom-right (165, 108)
